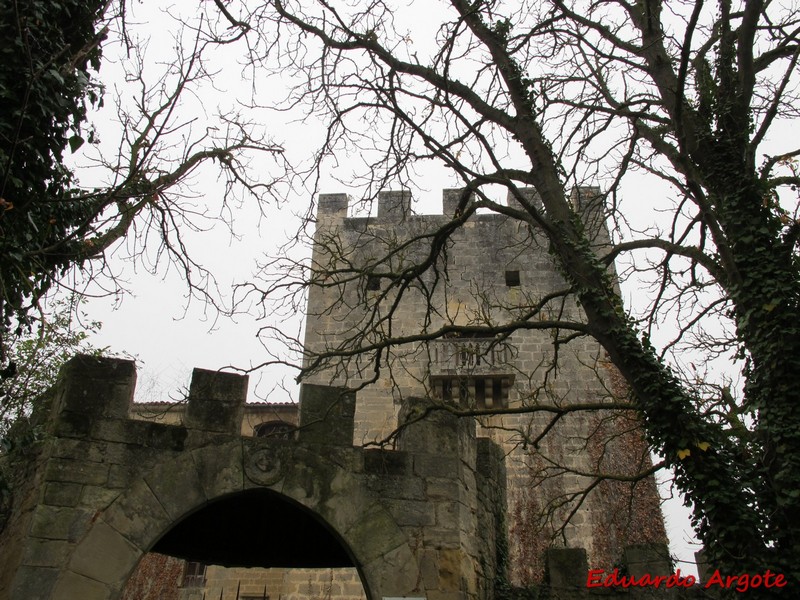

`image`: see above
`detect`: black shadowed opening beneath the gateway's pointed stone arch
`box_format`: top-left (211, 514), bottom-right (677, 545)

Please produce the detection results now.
top-left (152, 489), bottom-right (356, 568)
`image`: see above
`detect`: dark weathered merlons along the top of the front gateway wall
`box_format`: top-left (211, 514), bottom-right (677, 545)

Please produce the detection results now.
top-left (53, 355), bottom-right (474, 455)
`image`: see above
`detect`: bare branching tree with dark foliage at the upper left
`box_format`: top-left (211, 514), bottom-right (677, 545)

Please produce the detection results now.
top-left (0, 0), bottom-right (282, 366)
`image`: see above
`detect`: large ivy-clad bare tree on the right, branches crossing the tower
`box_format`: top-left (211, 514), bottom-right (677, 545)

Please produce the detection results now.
top-left (216, 0), bottom-right (800, 584)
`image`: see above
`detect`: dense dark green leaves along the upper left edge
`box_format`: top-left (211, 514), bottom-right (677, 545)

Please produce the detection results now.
top-left (0, 0), bottom-right (104, 338)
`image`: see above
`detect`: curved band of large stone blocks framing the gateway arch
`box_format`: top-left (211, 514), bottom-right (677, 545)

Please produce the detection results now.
top-left (48, 440), bottom-right (419, 600)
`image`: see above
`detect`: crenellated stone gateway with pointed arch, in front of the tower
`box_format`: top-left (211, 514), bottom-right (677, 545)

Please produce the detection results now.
top-left (0, 357), bottom-right (505, 600)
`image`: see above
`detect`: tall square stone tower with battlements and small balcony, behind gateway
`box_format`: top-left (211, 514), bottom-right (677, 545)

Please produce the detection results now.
top-left (304, 188), bottom-right (666, 584)
